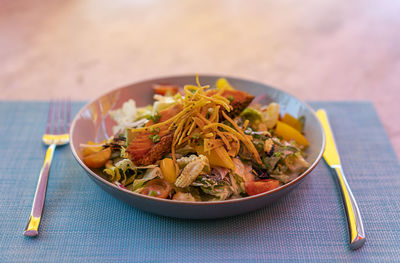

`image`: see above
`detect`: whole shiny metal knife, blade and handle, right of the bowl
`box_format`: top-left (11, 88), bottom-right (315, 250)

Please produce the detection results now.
top-left (317, 109), bottom-right (365, 249)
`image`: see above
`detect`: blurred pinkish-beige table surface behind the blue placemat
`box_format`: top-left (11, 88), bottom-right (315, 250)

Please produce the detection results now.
top-left (0, 0), bottom-right (400, 161)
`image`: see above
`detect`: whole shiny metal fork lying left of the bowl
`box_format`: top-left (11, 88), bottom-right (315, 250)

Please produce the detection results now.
top-left (24, 100), bottom-right (71, 237)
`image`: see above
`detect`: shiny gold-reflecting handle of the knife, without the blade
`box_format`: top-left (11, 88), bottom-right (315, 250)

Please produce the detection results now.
top-left (331, 165), bottom-right (365, 249)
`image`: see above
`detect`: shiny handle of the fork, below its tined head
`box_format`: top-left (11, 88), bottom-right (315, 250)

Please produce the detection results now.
top-left (24, 144), bottom-right (56, 237)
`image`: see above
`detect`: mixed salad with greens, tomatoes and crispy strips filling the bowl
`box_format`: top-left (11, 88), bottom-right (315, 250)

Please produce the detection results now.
top-left (81, 77), bottom-right (309, 201)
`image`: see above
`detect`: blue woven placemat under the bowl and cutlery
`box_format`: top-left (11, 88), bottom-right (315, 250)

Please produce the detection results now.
top-left (0, 102), bottom-right (400, 262)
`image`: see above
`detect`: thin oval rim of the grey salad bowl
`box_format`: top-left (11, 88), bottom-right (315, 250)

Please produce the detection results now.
top-left (69, 74), bottom-right (325, 206)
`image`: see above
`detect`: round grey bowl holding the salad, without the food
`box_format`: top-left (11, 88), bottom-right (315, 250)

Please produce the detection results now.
top-left (70, 75), bottom-right (325, 219)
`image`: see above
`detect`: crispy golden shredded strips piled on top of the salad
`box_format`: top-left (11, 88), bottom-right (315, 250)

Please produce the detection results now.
top-left (126, 76), bottom-right (261, 163)
